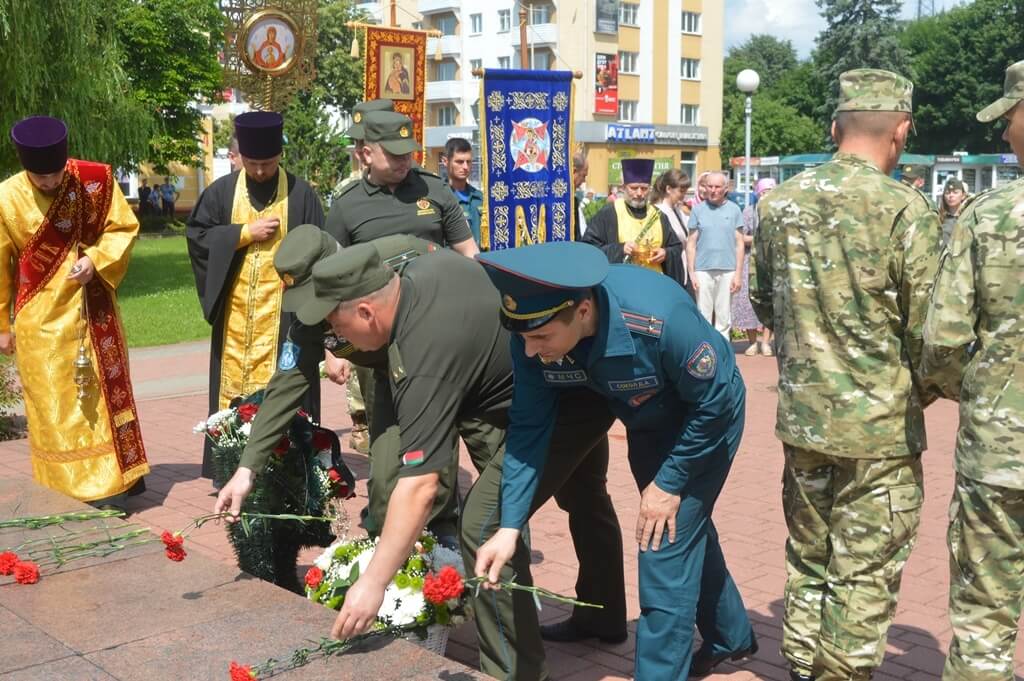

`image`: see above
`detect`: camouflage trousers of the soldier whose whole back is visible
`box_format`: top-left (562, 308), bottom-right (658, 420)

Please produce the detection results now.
top-left (782, 445), bottom-right (925, 681)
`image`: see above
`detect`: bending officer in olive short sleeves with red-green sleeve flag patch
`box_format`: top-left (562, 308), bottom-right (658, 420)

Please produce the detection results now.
top-left (288, 240), bottom-right (626, 681)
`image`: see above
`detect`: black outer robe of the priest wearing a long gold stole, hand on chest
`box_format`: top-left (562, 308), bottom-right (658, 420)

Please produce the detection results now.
top-left (185, 170), bottom-right (324, 478)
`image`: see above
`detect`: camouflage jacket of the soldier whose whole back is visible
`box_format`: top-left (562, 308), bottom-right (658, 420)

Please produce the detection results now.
top-left (750, 154), bottom-right (940, 459)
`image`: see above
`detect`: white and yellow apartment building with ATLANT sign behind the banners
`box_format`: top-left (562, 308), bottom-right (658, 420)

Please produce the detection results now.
top-left (360, 0), bottom-right (724, 195)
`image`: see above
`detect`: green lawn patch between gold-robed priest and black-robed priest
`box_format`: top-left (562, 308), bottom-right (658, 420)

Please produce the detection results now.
top-left (118, 237), bottom-right (210, 347)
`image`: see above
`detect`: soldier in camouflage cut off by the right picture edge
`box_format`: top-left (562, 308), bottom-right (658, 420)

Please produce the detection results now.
top-left (925, 61), bottom-right (1024, 681)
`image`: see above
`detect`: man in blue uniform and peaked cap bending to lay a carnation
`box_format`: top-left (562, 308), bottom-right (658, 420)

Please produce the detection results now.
top-left (475, 243), bottom-right (757, 681)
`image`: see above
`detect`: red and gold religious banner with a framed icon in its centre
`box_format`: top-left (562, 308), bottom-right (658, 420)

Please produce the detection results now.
top-left (362, 26), bottom-right (427, 163)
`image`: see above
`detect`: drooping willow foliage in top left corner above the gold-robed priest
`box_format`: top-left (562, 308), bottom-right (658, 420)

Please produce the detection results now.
top-left (0, 0), bottom-right (154, 177)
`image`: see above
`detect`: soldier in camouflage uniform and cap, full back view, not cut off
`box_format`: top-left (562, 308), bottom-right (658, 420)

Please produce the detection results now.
top-left (750, 69), bottom-right (940, 681)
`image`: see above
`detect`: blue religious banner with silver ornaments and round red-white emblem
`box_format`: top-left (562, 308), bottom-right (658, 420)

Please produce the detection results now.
top-left (480, 69), bottom-right (574, 251)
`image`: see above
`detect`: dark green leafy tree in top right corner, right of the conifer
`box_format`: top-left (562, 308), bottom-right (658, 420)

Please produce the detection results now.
top-left (901, 0), bottom-right (1024, 153)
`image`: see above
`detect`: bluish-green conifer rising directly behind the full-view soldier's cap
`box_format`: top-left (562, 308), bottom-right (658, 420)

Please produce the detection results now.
top-left (813, 0), bottom-right (910, 119)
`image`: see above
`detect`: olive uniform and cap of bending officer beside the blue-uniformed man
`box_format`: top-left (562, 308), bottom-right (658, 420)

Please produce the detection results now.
top-left (298, 242), bottom-right (626, 681)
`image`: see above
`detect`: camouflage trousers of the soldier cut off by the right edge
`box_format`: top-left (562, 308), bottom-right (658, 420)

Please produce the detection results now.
top-left (942, 474), bottom-right (1024, 681)
